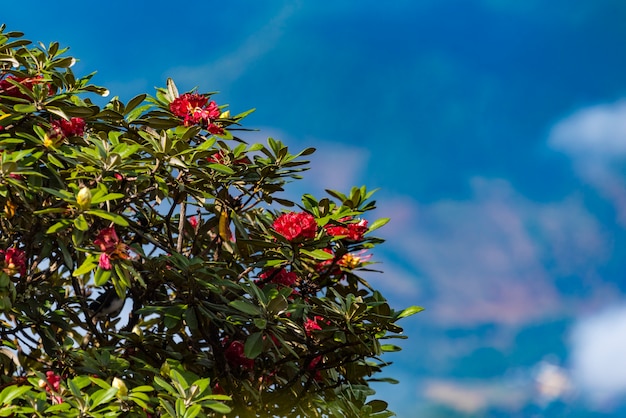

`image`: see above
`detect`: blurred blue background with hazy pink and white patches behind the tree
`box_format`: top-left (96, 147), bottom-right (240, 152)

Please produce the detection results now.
top-left (0, 0), bottom-right (626, 418)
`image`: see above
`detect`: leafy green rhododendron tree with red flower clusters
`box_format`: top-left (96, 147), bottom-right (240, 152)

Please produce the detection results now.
top-left (0, 26), bottom-right (421, 418)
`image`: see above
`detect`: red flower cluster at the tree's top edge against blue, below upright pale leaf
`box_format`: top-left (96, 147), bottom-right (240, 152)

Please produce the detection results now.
top-left (170, 93), bottom-right (224, 135)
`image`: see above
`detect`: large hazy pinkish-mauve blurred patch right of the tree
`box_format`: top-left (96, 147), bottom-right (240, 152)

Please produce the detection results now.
top-left (380, 179), bottom-right (608, 324)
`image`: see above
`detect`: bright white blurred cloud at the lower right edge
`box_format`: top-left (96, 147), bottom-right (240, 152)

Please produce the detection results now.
top-left (571, 306), bottom-right (626, 402)
